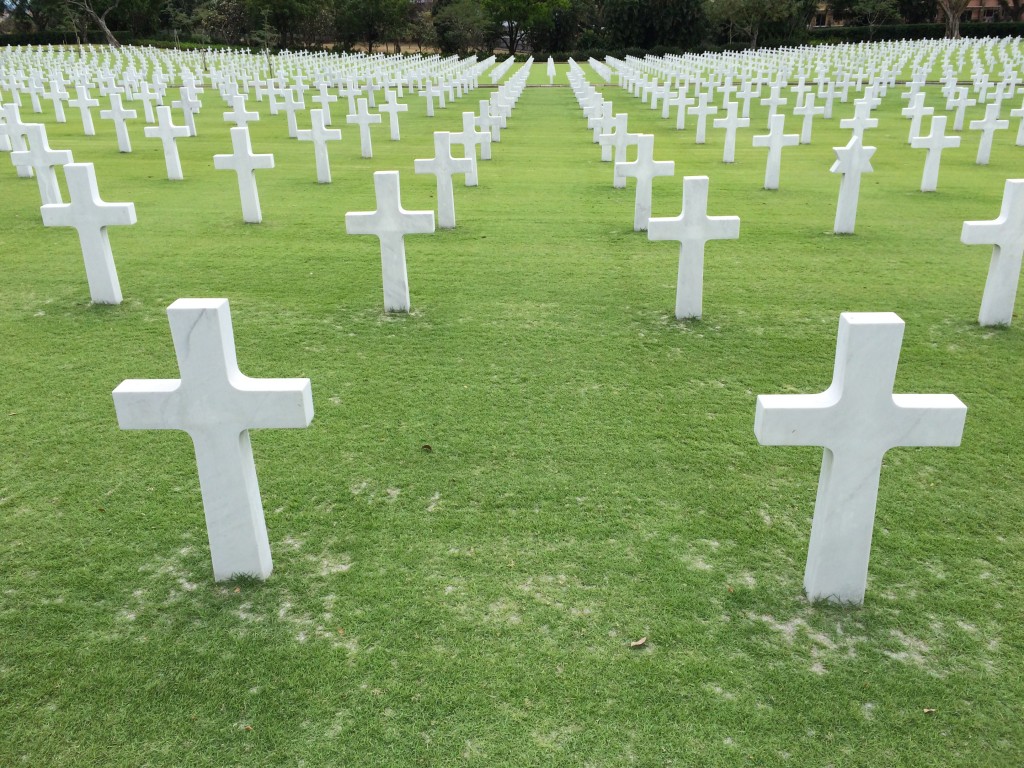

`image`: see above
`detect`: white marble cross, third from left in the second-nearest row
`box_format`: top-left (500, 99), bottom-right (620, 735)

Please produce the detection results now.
top-left (647, 176), bottom-right (739, 319)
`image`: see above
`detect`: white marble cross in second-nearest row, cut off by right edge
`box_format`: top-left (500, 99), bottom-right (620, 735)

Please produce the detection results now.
top-left (961, 179), bottom-right (1024, 326)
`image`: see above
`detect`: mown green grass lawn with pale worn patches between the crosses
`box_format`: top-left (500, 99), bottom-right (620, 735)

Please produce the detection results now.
top-left (0, 55), bottom-right (1024, 768)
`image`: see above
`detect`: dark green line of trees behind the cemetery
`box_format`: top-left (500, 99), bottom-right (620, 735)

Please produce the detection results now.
top-left (0, 0), bottom-right (1007, 55)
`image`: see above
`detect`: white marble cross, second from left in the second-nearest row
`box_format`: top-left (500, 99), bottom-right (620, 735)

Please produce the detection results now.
top-left (345, 171), bottom-right (434, 312)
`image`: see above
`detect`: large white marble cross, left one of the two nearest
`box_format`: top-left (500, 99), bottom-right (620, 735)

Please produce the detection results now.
top-left (114, 299), bottom-right (313, 582)
